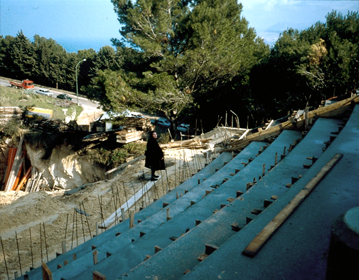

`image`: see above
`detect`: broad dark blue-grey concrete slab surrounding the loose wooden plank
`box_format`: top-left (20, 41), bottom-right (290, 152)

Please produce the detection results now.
top-left (183, 105), bottom-right (359, 280)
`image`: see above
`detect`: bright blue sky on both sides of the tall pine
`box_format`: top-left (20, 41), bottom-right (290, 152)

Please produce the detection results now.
top-left (0, 0), bottom-right (359, 52)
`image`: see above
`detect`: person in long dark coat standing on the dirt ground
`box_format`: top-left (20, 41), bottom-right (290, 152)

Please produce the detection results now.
top-left (145, 131), bottom-right (165, 181)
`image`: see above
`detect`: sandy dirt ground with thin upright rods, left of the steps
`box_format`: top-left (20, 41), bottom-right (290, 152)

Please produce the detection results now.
top-left (0, 150), bottom-right (217, 279)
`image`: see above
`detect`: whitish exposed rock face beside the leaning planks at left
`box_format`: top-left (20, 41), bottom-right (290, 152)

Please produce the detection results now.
top-left (25, 143), bottom-right (106, 189)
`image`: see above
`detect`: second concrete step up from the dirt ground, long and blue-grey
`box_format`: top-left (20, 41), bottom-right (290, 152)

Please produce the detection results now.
top-left (47, 142), bottom-right (266, 279)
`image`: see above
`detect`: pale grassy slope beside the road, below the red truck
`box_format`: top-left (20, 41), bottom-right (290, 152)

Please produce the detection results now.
top-left (0, 86), bottom-right (83, 120)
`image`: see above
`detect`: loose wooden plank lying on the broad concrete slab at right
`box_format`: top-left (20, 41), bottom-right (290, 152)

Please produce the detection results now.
top-left (243, 154), bottom-right (343, 257)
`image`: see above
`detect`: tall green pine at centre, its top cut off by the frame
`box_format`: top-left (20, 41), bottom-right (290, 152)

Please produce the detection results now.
top-left (101, 0), bottom-right (267, 128)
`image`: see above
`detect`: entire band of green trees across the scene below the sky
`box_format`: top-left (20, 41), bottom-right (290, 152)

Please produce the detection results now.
top-left (0, 6), bottom-right (359, 130)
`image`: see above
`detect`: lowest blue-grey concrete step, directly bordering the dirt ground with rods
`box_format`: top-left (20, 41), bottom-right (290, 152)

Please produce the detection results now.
top-left (18, 152), bottom-right (232, 279)
